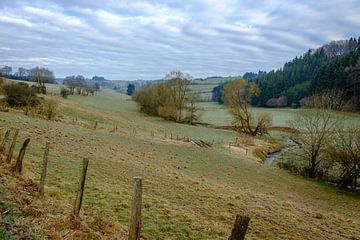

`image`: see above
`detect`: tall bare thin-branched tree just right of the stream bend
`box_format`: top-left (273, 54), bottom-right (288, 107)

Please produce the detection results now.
top-left (291, 91), bottom-right (342, 178)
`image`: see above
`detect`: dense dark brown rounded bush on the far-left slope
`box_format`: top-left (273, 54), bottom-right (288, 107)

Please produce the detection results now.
top-left (4, 83), bottom-right (39, 107)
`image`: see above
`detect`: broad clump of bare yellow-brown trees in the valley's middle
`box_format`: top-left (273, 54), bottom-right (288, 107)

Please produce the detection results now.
top-left (133, 71), bottom-right (200, 124)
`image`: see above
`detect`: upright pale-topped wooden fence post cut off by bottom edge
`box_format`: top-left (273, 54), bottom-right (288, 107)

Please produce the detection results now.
top-left (128, 177), bottom-right (142, 240)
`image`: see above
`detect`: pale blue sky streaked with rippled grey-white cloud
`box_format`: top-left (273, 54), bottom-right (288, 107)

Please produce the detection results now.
top-left (0, 0), bottom-right (360, 80)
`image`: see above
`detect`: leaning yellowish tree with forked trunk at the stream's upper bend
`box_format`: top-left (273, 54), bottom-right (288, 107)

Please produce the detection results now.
top-left (223, 79), bottom-right (271, 136)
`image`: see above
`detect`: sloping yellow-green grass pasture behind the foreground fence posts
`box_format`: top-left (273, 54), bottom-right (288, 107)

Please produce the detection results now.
top-left (0, 86), bottom-right (360, 239)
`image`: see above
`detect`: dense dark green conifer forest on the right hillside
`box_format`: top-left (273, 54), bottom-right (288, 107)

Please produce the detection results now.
top-left (251, 38), bottom-right (360, 111)
